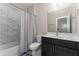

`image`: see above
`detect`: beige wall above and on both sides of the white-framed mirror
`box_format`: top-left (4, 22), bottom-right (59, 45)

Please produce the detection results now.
top-left (48, 3), bottom-right (79, 33)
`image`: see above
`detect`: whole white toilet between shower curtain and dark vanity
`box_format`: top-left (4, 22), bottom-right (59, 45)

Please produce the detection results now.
top-left (29, 35), bottom-right (41, 56)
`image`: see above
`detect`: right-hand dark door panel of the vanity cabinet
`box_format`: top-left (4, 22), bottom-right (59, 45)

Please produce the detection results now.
top-left (55, 46), bottom-right (76, 56)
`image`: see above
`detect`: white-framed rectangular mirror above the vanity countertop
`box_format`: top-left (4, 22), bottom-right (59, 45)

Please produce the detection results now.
top-left (56, 15), bottom-right (71, 33)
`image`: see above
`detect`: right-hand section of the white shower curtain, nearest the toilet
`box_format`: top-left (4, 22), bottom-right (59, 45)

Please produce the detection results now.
top-left (27, 13), bottom-right (36, 48)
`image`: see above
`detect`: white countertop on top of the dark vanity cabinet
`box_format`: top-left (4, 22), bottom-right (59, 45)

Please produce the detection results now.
top-left (42, 32), bottom-right (79, 42)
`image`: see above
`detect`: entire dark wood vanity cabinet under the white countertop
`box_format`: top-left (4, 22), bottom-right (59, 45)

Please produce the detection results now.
top-left (41, 37), bottom-right (79, 56)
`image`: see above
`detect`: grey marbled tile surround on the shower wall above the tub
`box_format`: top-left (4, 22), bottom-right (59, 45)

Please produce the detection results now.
top-left (0, 4), bottom-right (21, 49)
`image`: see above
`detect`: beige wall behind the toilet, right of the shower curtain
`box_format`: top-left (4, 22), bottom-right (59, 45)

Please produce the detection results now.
top-left (28, 4), bottom-right (47, 35)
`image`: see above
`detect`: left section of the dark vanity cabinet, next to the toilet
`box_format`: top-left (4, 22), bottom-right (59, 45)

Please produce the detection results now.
top-left (41, 38), bottom-right (53, 56)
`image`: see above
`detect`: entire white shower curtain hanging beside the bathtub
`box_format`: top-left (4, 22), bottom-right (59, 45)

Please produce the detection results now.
top-left (20, 12), bottom-right (36, 54)
